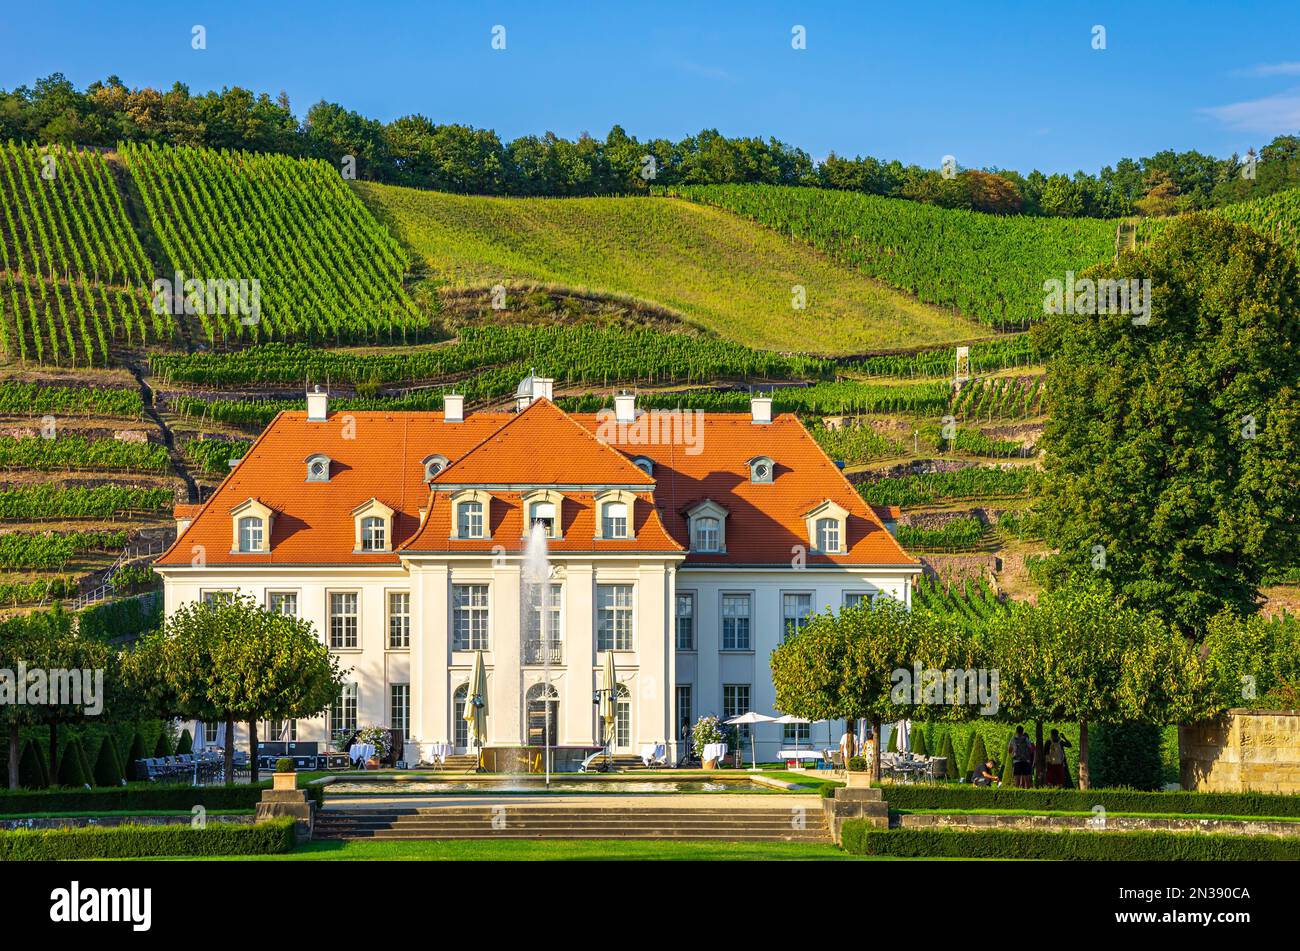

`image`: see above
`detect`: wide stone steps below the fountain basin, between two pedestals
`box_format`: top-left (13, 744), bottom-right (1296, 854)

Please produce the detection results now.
top-left (315, 796), bottom-right (831, 843)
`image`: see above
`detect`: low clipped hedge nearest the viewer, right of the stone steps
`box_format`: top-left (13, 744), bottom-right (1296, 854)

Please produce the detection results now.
top-left (841, 818), bottom-right (1300, 861)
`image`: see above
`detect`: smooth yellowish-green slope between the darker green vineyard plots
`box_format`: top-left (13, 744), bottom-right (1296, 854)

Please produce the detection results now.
top-left (356, 182), bottom-right (988, 353)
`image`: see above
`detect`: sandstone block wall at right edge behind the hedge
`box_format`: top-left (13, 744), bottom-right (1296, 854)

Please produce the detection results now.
top-left (1178, 709), bottom-right (1300, 793)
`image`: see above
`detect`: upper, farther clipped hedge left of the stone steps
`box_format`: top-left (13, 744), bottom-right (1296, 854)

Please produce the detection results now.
top-left (0, 782), bottom-right (325, 816)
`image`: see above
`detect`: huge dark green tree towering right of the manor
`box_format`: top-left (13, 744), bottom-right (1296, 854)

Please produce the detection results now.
top-left (1041, 216), bottom-right (1300, 631)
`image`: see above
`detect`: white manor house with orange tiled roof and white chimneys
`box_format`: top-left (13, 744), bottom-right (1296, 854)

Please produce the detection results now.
top-left (156, 377), bottom-right (920, 764)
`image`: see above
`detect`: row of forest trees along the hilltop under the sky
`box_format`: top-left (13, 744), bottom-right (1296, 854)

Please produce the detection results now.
top-left (0, 73), bottom-right (1300, 218)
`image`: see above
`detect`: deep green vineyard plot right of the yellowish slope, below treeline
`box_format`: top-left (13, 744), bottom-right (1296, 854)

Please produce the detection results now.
top-left (663, 184), bottom-right (1115, 329)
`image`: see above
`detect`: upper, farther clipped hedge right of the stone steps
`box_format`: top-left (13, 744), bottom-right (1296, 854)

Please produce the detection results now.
top-left (885, 785), bottom-right (1300, 817)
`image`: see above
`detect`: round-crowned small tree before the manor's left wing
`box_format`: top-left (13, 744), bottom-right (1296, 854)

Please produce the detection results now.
top-left (129, 596), bottom-right (343, 782)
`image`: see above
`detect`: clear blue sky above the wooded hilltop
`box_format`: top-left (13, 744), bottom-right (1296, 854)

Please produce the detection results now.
top-left (0, 0), bottom-right (1300, 171)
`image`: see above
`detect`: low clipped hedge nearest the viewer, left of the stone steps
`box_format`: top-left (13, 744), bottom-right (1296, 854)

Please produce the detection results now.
top-left (0, 818), bottom-right (294, 861)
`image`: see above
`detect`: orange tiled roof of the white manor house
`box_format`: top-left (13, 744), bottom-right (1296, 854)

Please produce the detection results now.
top-left (157, 400), bottom-right (918, 568)
